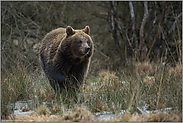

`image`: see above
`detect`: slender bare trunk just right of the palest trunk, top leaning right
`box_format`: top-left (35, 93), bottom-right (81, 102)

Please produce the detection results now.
top-left (138, 2), bottom-right (148, 61)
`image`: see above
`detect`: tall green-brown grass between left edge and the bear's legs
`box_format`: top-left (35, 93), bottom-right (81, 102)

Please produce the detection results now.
top-left (1, 63), bottom-right (54, 119)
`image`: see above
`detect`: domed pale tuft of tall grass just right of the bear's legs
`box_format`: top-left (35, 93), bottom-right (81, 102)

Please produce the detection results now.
top-left (81, 71), bottom-right (129, 112)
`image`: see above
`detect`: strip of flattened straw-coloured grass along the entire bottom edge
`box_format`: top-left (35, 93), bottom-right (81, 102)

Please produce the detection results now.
top-left (2, 111), bottom-right (182, 122)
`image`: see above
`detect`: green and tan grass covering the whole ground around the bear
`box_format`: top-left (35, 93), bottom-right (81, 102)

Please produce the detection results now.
top-left (1, 62), bottom-right (182, 122)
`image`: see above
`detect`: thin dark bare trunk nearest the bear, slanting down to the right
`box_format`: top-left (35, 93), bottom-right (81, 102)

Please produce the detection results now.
top-left (110, 1), bottom-right (126, 65)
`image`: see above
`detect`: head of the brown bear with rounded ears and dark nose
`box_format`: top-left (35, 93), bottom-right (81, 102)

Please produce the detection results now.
top-left (61, 26), bottom-right (93, 58)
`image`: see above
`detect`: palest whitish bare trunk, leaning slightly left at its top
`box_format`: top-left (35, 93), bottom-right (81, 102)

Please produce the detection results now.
top-left (129, 1), bottom-right (138, 60)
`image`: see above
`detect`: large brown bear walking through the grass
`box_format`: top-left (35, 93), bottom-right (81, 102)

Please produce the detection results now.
top-left (40, 26), bottom-right (94, 92)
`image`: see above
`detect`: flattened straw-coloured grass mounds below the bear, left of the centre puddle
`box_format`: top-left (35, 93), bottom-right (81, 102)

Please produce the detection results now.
top-left (3, 106), bottom-right (98, 122)
